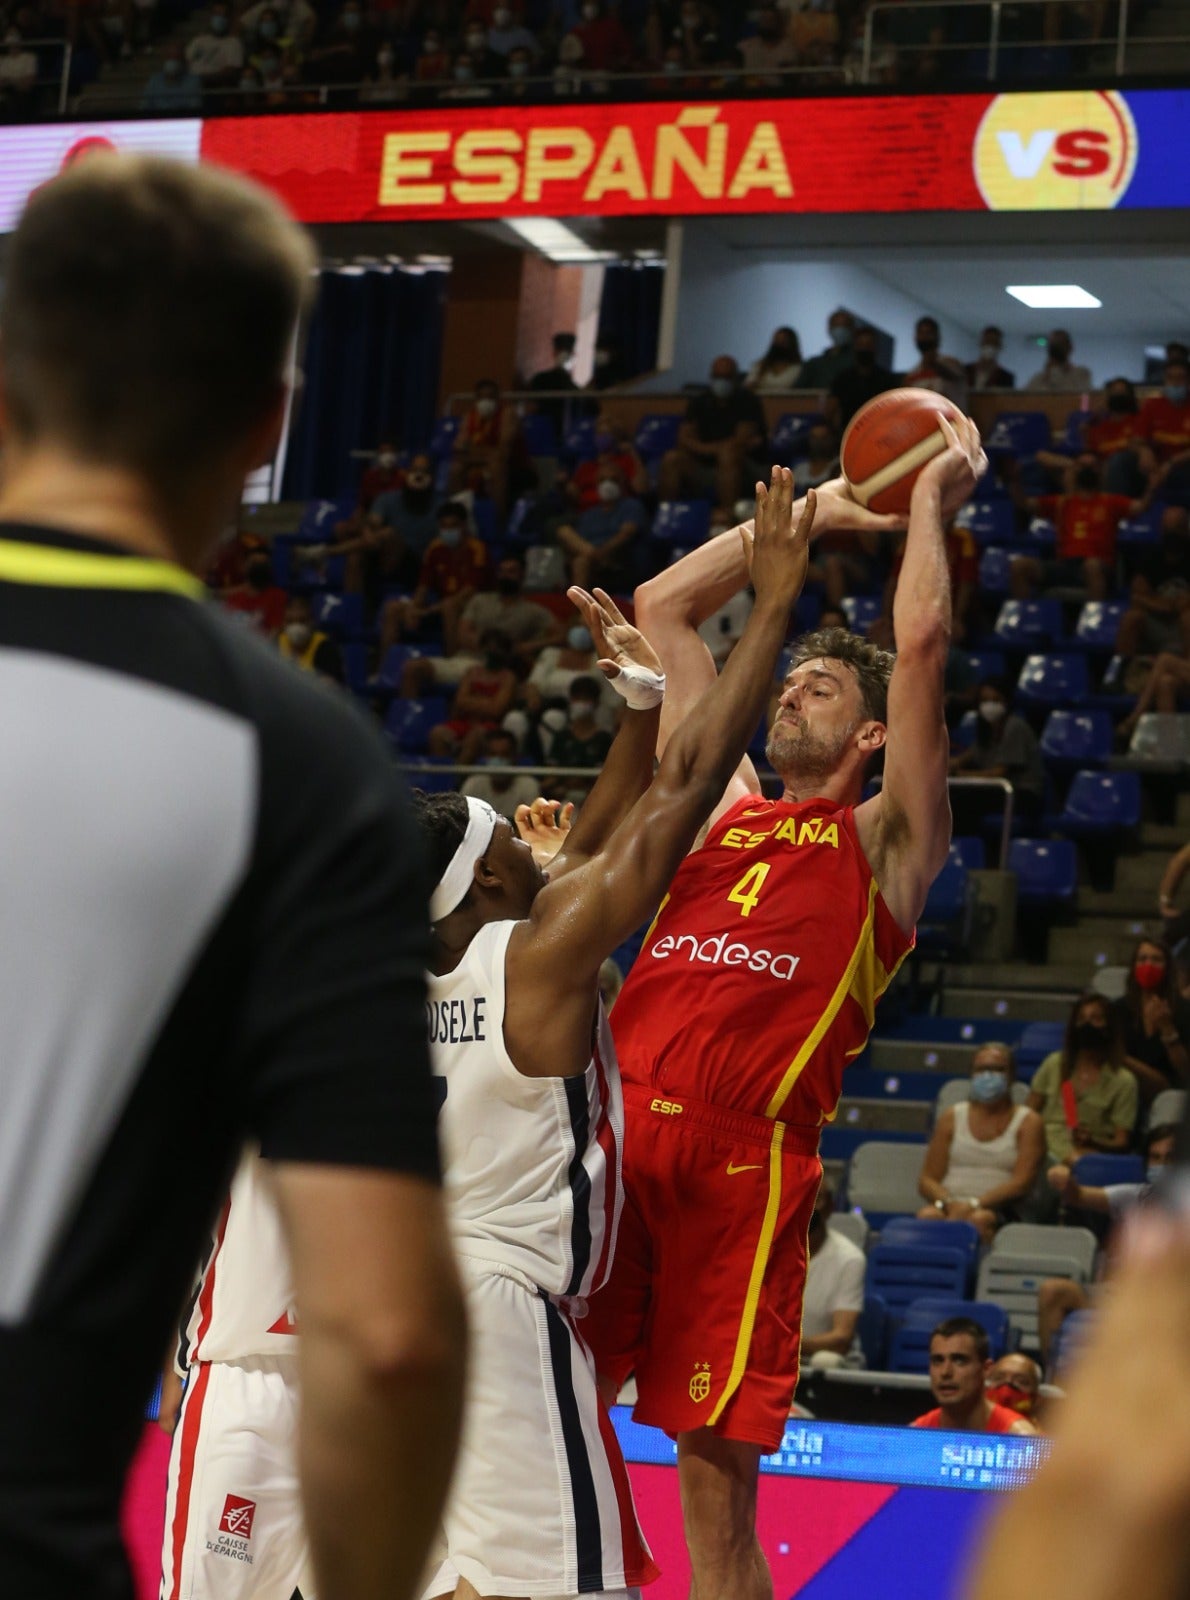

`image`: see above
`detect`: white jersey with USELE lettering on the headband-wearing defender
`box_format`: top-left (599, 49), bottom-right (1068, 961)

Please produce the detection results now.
top-left (429, 922), bottom-right (624, 1298)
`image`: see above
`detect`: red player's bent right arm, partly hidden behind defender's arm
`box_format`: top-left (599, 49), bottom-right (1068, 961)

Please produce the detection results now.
top-left (635, 478), bottom-right (904, 811)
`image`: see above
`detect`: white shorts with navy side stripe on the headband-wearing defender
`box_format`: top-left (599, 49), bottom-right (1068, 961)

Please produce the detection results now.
top-left (425, 1259), bottom-right (656, 1600)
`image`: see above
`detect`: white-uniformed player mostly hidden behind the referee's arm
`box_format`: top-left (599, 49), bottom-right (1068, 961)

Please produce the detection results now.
top-left (160, 1149), bottom-right (315, 1600)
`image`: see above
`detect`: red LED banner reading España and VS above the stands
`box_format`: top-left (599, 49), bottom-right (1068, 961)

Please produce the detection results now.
top-left (0, 90), bottom-right (1190, 230)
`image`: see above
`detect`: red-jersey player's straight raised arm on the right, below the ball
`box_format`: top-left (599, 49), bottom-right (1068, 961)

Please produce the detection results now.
top-left (856, 418), bottom-right (987, 933)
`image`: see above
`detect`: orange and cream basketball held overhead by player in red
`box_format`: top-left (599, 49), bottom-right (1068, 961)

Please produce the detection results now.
top-left (840, 389), bottom-right (961, 514)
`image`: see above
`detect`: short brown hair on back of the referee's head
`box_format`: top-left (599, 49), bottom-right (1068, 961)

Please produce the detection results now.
top-left (0, 150), bottom-right (315, 490)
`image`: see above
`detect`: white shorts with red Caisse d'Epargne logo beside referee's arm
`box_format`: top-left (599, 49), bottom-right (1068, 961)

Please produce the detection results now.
top-left (162, 1355), bottom-right (313, 1600)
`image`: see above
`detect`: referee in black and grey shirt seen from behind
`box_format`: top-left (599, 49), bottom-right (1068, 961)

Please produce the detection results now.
top-left (0, 154), bottom-right (464, 1600)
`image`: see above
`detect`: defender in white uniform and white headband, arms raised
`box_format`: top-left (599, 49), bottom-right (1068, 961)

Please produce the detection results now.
top-left (417, 467), bottom-right (814, 1600)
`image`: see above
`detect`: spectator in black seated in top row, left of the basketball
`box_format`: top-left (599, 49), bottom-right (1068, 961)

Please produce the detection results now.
top-left (657, 355), bottom-right (768, 510)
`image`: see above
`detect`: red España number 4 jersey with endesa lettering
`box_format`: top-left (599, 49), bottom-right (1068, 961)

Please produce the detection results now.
top-left (611, 795), bottom-right (913, 1123)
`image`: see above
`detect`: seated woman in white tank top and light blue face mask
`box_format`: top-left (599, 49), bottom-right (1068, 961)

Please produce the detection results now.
top-left (918, 1043), bottom-right (1046, 1245)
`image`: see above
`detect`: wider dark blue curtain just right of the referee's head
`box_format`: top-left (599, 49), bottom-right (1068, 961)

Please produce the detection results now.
top-left (282, 267), bottom-right (446, 499)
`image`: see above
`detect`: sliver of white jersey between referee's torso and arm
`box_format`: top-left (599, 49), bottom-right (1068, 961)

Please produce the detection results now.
top-left (182, 1149), bottom-right (298, 1366)
